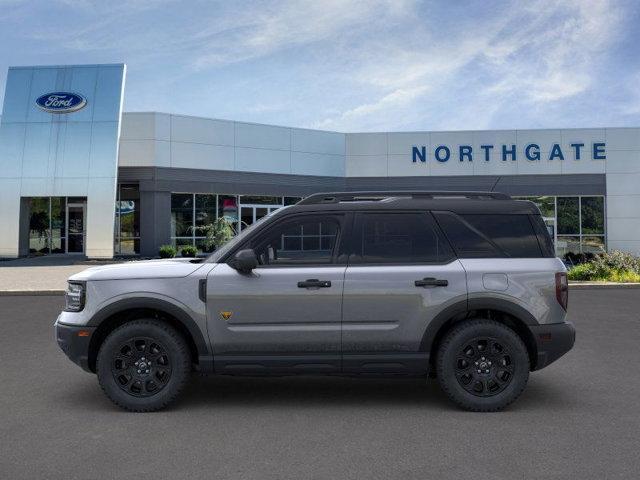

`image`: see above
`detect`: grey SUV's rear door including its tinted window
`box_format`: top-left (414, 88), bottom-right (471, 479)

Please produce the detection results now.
top-left (342, 211), bottom-right (467, 373)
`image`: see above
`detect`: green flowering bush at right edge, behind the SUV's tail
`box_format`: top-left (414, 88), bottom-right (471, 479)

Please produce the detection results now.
top-left (568, 250), bottom-right (640, 282)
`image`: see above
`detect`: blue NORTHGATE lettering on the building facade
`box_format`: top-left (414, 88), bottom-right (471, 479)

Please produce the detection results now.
top-left (411, 142), bottom-right (607, 163)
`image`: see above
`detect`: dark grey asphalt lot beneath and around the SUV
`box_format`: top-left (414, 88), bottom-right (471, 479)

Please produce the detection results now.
top-left (0, 289), bottom-right (640, 480)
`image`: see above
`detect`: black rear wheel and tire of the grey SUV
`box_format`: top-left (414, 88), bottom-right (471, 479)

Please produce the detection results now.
top-left (436, 319), bottom-right (529, 412)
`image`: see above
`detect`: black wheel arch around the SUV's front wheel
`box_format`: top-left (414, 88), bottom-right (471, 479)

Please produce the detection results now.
top-left (88, 298), bottom-right (212, 373)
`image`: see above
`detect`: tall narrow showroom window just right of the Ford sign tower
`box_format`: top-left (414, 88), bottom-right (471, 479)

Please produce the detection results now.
top-left (114, 185), bottom-right (140, 255)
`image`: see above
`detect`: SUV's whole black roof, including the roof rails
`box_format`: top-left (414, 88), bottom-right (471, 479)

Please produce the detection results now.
top-left (287, 191), bottom-right (540, 215)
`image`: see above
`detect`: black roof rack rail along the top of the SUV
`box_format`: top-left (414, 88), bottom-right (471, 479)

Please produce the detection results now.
top-left (297, 190), bottom-right (511, 205)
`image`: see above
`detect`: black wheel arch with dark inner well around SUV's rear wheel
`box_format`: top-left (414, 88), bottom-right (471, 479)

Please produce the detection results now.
top-left (420, 298), bottom-right (539, 370)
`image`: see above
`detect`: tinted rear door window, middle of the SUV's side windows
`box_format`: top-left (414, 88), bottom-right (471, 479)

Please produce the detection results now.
top-left (351, 213), bottom-right (453, 263)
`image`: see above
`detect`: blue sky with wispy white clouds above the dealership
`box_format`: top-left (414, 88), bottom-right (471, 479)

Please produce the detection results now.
top-left (0, 0), bottom-right (640, 132)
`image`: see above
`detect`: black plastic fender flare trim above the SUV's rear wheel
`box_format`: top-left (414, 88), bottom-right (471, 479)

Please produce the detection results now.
top-left (420, 298), bottom-right (539, 352)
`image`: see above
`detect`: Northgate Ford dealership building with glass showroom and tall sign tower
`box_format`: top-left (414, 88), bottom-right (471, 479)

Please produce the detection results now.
top-left (0, 64), bottom-right (640, 258)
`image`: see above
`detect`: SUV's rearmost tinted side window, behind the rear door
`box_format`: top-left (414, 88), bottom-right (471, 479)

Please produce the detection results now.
top-left (436, 213), bottom-right (543, 258)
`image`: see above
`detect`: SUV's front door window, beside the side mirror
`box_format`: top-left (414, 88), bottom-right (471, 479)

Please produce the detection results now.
top-left (249, 215), bottom-right (340, 266)
